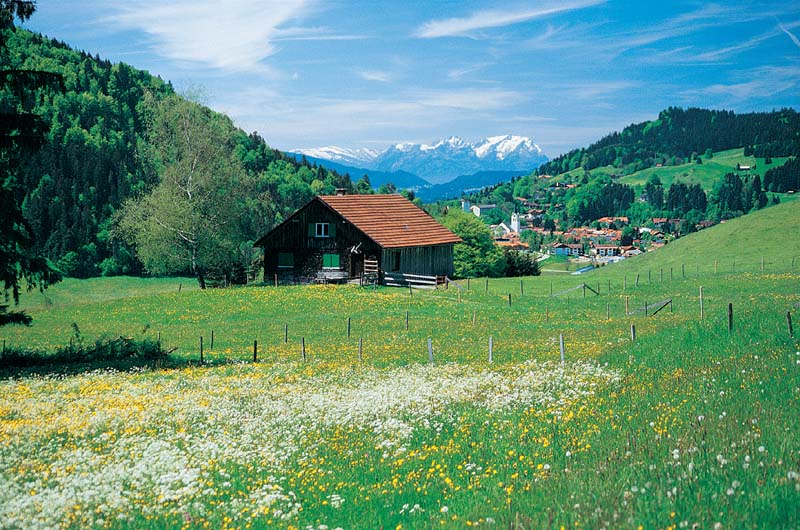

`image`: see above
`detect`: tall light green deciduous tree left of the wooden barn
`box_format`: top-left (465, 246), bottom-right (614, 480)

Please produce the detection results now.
top-left (116, 96), bottom-right (245, 289)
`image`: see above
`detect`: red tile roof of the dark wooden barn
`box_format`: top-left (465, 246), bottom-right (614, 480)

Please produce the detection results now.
top-left (317, 195), bottom-right (461, 248)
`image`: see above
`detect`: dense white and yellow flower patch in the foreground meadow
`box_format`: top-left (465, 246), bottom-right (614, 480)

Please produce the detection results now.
top-left (0, 361), bottom-right (619, 528)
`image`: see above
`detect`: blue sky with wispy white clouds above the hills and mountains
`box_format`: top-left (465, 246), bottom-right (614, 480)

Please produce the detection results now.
top-left (25, 0), bottom-right (800, 156)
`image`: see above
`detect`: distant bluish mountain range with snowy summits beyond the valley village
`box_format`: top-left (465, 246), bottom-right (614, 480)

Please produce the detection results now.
top-left (293, 135), bottom-right (549, 196)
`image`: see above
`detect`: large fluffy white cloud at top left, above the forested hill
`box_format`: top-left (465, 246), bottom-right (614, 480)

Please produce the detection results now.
top-left (111, 0), bottom-right (308, 71)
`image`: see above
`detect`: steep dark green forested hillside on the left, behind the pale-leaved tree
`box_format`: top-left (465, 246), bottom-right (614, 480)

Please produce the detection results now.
top-left (8, 28), bottom-right (353, 277)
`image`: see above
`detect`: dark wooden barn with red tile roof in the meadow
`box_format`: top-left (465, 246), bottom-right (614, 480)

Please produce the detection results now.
top-left (255, 194), bottom-right (461, 284)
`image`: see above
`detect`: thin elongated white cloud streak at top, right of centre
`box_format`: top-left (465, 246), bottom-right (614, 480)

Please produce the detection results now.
top-left (415, 0), bottom-right (604, 38)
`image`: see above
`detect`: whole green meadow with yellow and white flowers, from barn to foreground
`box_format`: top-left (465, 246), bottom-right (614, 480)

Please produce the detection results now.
top-left (0, 202), bottom-right (800, 529)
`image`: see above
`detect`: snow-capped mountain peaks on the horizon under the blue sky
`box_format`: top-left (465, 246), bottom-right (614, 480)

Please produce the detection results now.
top-left (295, 135), bottom-right (548, 184)
